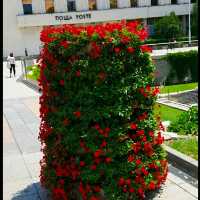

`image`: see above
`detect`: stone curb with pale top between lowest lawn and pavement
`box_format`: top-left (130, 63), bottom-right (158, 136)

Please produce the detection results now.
top-left (163, 145), bottom-right (198, 179)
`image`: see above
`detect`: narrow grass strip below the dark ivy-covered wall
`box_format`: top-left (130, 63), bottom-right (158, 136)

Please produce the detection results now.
top-left (160, 82), bottom-right (198, 94)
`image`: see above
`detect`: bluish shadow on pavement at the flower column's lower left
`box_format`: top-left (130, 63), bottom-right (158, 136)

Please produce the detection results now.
top-left (11, 182), bottom-right (51, 200)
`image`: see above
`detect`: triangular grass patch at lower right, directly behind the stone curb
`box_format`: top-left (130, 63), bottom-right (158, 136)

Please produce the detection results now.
top-left (165, 137), bottom-right (198, 160)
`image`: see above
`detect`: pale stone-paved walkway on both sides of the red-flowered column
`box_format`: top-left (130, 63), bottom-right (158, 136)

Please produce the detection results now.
top-left (3, 61), bottom-right (198, 200)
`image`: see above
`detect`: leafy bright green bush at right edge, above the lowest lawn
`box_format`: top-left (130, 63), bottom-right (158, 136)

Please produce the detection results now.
top-left (168, 106), bottom-right (198, 135)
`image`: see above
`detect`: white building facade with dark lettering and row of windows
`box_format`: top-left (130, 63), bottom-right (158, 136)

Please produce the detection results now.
top-left (3, 0), bottom-right (192, 57)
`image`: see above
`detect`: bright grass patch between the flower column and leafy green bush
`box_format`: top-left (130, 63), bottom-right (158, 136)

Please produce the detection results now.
top-left (154, 103), bottom-right (185, 122)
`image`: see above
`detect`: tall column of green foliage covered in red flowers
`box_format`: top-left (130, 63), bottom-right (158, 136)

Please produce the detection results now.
top-left (39, 21), bottom-right (167, 200)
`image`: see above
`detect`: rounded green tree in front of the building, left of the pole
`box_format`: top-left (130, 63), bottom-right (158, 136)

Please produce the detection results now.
top-left (155, 12), bottom-right (182, 40)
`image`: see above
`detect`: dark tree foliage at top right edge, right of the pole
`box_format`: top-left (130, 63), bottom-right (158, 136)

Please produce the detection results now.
top-left (191, 1), bottom-right (198, 37)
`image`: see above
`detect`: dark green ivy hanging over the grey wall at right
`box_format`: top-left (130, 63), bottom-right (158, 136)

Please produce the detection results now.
top-left (166, 50), bottom-right (198, 83)
